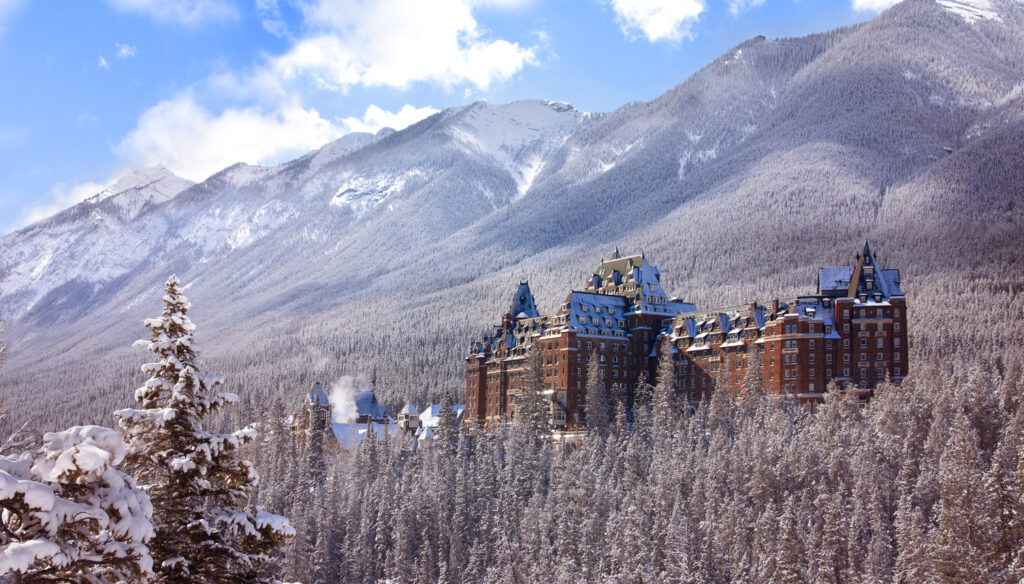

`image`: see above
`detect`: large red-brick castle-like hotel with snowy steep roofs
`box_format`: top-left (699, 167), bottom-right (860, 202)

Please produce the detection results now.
top-left (464, 243), bottom-right (907, 428)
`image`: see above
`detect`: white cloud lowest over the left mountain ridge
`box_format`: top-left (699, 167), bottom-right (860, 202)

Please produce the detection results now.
top-left (114, 93), bottom-right (344, 180)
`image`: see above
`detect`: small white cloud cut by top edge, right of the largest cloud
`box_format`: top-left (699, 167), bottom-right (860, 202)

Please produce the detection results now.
top-left (611, 0), bottom-right (705, 43)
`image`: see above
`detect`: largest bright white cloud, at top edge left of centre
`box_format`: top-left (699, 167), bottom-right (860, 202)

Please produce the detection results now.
top-left (276, 0), bottom-right (540, 91)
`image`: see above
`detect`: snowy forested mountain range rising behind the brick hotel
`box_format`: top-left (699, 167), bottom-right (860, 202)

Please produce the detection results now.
top-left (0, 0), bottom-right (1024, 422)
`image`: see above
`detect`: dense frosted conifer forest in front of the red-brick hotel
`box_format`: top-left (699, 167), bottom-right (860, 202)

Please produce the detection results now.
top-left (249, 334), bottom-right (1024, 583)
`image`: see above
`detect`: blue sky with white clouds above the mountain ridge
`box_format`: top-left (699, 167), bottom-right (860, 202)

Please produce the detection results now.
top-left (0, 0), bottom-right (897, 234)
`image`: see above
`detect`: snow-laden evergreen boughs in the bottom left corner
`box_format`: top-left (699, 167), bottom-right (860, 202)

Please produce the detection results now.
top-left (0, 426), bottom-right (153, 584)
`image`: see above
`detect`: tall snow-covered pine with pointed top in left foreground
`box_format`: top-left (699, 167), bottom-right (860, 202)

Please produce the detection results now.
top-left (115, 276), bottom-right (294, 584)
